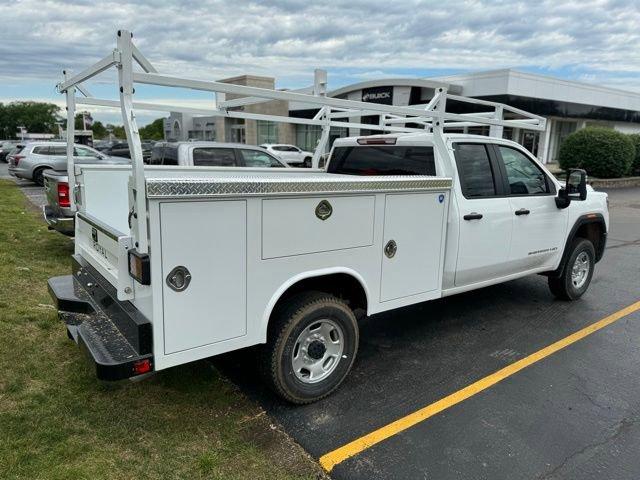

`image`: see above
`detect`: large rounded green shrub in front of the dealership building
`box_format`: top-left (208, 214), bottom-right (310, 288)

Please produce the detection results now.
top-left (558, 128), bottom-right (636, 178)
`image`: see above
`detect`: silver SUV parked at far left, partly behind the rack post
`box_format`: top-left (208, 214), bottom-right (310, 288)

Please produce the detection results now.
top-left (9, 142), bottom-right (131, 185)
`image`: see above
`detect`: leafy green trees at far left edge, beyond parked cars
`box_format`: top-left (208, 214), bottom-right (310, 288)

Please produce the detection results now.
top-left (0, 102), bottom-right (60, 138)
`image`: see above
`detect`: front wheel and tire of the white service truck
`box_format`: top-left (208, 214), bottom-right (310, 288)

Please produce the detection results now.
top-left (549, 238), bottom-right (596, 300)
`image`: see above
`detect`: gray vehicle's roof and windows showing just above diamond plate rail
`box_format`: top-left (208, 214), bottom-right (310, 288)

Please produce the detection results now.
top-left (149, 142), bottom-right (287, 168)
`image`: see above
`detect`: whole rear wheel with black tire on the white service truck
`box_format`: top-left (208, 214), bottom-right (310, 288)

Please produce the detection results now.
top-left (258, 292), bottom-right (359, 405)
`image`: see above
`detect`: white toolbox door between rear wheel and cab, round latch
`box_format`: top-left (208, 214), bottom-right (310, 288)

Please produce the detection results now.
top-left (380, 192), bottom-right (447, 302)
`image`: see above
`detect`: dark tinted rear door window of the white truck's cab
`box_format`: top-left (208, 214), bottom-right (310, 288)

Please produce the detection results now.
top-left (455, 143), bottom-right (496, 198)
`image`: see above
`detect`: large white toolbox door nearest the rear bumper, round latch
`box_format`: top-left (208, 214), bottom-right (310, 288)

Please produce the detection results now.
top-left (160, 200), bottom-right (247, 354)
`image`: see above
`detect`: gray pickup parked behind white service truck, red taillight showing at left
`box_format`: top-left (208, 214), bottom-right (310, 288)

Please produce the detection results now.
top-left (42, 142), bottom-right (285, 235)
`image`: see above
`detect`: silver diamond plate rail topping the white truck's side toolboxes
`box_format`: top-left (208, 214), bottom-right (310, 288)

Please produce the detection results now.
top-left (147, 176), bottom-right (451, 198)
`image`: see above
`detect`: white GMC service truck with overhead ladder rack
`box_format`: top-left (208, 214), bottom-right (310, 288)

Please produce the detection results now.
top-left (49, 31), bottom-right (608, 404)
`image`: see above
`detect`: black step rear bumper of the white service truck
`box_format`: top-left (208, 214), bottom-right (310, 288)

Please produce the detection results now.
top-left (48, 255), bottom-right (153, 380)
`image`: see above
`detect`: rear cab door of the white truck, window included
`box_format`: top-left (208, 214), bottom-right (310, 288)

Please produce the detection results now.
top-left (454, 142), bottom-right (513, 287)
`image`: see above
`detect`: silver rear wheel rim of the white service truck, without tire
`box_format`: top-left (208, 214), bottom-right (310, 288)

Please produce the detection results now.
top-left (291, 318), bottom-right (344, 383)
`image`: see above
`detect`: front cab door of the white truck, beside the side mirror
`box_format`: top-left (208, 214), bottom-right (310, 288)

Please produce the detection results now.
top-left (493, 145), bottom-right (568, 272)
